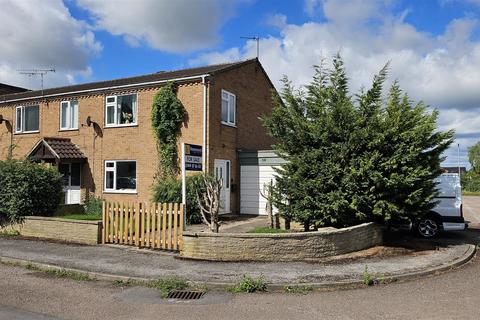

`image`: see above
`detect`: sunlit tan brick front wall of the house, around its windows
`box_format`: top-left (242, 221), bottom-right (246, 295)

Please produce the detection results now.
top-left (0, 82), bottom-right (203, 201)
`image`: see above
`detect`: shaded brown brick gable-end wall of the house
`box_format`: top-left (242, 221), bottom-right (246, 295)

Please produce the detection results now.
top-left (208, 62), bottom-right (273, 212)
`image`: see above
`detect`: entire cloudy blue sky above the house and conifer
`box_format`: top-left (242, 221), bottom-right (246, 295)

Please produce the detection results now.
top-left (0, 0), bottom-right (480, 165)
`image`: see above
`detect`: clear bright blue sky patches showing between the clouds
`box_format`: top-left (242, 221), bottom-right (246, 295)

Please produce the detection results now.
top-left (65, 0), bottom-right (480, 81)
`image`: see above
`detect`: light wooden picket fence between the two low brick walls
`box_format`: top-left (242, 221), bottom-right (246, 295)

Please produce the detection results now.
top-left (102, 201), bottom-right (184, 251)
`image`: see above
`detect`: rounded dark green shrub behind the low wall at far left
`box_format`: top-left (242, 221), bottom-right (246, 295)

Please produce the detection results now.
top-left (0, 159), bottom-right (63, 226)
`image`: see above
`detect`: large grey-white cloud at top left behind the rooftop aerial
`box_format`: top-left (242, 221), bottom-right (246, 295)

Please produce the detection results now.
top-left (0, 0), bottom-right (102, 88)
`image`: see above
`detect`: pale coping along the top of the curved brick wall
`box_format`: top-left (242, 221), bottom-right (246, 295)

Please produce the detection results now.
top-left (183, 222), bottom-right (376, 239)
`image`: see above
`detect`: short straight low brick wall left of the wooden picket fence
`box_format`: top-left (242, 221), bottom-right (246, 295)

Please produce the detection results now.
top-left (0, 217), bottom-right (102, 244)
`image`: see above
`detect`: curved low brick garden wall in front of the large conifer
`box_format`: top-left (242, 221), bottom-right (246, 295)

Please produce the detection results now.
top-left (180, 223), bottom-right (383, 261)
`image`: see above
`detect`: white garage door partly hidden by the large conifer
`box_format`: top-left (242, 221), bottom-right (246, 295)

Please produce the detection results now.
top-left (240, 165), bottom-right (275, 215)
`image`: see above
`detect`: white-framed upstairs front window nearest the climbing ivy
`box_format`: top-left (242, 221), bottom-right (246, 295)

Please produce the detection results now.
top-left (105, 94), bottom-right (137, 127)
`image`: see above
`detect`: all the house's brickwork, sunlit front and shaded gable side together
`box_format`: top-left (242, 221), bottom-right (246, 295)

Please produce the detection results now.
top-left (0, 62), bottom-right (272, 212)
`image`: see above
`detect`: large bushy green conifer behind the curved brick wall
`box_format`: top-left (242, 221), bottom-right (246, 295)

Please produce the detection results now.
top-left (263, 55), bottom-right (453, 230)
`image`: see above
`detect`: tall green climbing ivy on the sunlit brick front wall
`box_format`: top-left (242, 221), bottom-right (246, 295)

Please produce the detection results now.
top-left (151, 82), bottom-right (185, 178)
